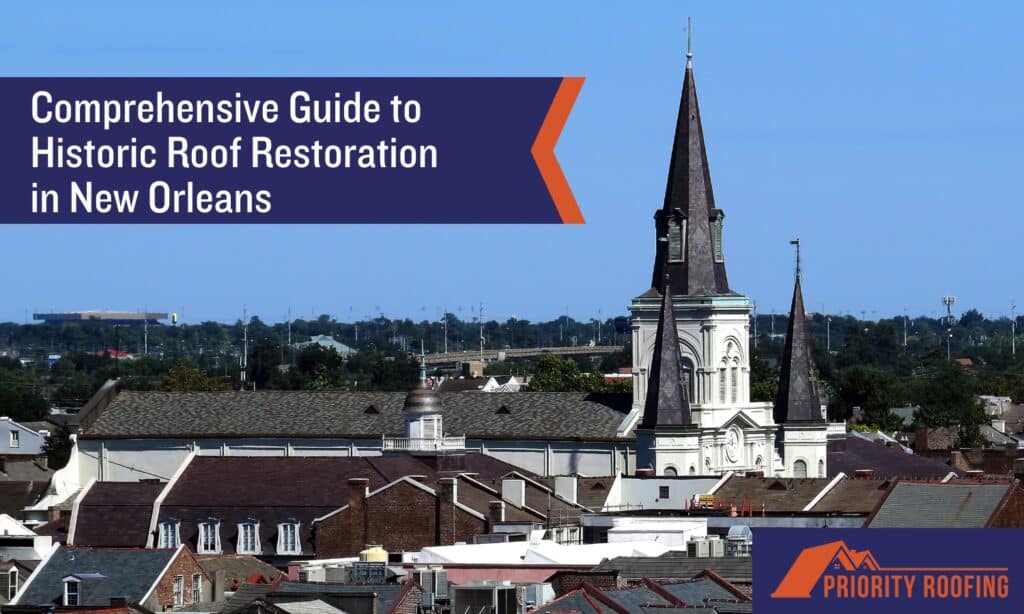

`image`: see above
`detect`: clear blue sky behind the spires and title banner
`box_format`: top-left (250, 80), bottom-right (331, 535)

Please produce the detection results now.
top-left (0, 1), bottom-right (1024, 321)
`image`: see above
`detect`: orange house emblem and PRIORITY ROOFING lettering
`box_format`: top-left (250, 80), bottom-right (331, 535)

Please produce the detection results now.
top-left (771, 540), bottom-right (1010, 601)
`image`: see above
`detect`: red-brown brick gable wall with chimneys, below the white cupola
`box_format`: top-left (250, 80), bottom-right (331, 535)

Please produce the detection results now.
top-left (314, 480), bottom-right (487, 558)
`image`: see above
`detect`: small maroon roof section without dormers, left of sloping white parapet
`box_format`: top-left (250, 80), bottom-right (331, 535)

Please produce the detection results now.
top-left (75, 482), bottom-right (165, 547)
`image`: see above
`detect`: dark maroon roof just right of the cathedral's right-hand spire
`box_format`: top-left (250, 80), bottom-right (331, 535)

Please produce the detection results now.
top-left (828, 435), bottom-right (958, 479)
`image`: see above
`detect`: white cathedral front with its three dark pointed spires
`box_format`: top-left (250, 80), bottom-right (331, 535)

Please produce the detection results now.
top-left (630, 40), bottom-right (826, 477)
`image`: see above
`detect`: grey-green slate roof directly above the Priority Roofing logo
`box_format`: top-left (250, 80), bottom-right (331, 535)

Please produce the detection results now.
top-left (866, 482), bottom-right (1013, 529)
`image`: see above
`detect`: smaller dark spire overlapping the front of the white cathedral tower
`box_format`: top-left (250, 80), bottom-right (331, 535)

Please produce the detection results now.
top-left (641, 284), bottom-right (692, 429)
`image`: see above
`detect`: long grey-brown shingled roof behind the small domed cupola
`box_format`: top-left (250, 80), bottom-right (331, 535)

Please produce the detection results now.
top-left (82, 391), bottom-right (632, 440)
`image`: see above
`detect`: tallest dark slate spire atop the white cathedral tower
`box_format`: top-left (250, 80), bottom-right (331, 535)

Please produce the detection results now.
top-left (651, 38), bottom-right (729, 295)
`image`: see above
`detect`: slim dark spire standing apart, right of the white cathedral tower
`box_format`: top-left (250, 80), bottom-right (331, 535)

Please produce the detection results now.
top-left (775, 274), bottom-right (822, 424)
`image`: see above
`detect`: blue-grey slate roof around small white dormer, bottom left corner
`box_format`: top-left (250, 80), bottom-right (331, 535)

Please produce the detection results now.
top-left (17, 546), bottom-right (178, 606)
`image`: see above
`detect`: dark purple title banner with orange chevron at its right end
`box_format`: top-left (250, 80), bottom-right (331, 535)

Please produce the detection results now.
top-left (0, 78), bottom-right (583, 224)
